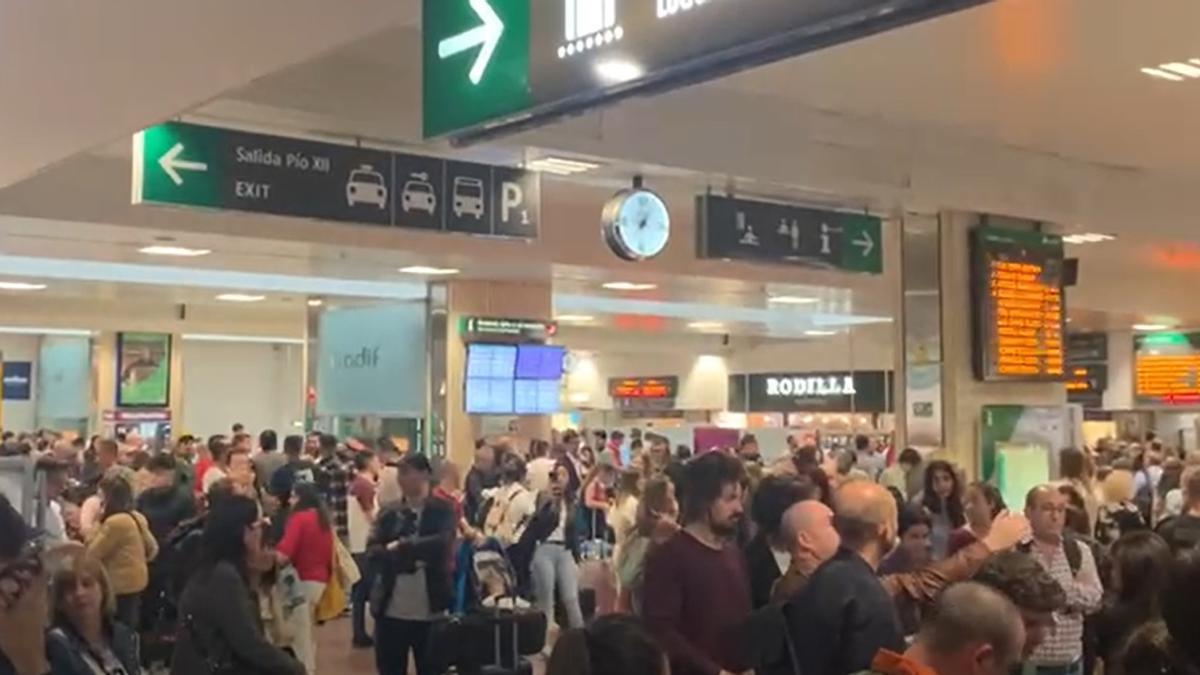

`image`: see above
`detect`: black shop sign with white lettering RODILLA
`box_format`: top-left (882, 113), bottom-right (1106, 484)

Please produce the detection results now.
top-left (730, 370), bottom-right (892, 412)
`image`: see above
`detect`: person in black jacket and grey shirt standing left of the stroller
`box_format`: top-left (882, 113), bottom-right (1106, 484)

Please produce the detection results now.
top-left (367, 454), bottom-right (457, 675)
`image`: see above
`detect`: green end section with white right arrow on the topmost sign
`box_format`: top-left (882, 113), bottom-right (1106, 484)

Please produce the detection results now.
top-left (422, 0), bottom-right (533, 137)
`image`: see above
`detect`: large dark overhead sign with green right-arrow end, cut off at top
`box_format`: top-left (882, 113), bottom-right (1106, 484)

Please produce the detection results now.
top-left (421, 0), bottom-right (985, 138)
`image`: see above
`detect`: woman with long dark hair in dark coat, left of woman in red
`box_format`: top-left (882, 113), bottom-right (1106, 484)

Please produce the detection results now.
top-left (170, 495), bottom-right (305, 675)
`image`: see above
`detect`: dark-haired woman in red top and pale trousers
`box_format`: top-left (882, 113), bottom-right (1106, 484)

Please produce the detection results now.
top-left (275, 483), bottom-right (334, 674)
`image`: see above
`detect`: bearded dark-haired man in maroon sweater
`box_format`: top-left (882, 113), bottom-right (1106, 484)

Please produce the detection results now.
top-left (644, 453), bottom-right (751, 675)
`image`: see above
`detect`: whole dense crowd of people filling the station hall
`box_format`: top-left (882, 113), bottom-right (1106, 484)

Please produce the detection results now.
top-left (0, 425), bottom-right (1200, 675)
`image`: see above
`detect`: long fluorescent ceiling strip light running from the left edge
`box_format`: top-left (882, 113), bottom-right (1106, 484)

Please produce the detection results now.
top-left (0, 255), bottom-right (426, 300)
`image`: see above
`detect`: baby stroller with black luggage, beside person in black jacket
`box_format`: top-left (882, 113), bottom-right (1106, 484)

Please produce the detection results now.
top-left (430, 540), bottom-right (546, 675)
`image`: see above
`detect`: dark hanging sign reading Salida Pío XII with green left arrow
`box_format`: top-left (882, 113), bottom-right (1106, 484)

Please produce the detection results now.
top-left (133, 123), bottom-right (541, 239)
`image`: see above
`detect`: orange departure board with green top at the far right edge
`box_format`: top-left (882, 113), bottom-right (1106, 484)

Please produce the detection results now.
top-left (1134, 331), bottom-right (1200, 405)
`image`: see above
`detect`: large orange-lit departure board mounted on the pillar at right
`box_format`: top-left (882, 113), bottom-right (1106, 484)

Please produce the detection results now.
top-left (972, 227), bottom-right (1066, 381)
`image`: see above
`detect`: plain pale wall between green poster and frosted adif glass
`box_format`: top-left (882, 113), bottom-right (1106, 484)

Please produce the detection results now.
top-left (176, 340), bottom-right (304, 437)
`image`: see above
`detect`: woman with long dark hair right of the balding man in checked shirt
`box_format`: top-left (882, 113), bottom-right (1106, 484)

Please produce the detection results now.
top-left (1096, 530), bottom-right (1171, 664)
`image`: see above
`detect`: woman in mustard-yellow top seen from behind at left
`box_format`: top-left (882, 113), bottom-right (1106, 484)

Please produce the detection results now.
top-left (88, 476), bottom-right (158, 631)
